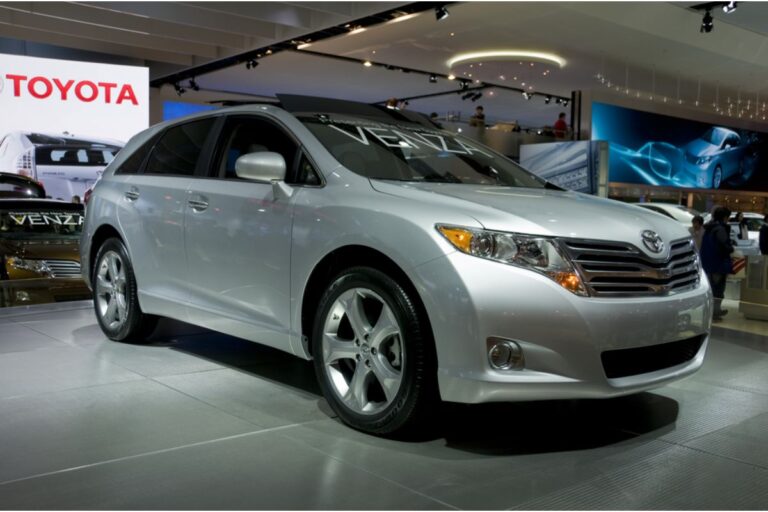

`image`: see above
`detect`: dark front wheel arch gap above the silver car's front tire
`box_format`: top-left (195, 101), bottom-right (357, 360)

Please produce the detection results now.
top-left (301, 245), bottom-right (434, 355)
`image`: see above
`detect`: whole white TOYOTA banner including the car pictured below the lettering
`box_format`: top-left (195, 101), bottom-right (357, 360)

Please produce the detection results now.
top-left (0, 54), bottom-right (149, 200)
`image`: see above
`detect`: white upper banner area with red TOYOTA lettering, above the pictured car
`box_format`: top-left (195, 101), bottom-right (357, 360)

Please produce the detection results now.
top-left (0, 54), bottom-right (149, 143)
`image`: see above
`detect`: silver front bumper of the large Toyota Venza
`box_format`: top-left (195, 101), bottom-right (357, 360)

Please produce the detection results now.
top-left (415, 253), bottom-right (711, 403)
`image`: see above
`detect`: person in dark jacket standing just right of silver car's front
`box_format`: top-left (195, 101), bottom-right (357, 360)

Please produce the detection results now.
top-left (699, 206), bottom-right (733, 321)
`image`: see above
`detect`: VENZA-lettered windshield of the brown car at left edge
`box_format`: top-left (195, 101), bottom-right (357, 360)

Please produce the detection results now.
top-left (0, 209), bottom-right (83, 240)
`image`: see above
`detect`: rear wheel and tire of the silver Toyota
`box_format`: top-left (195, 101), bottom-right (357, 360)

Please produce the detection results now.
top-left (92, 238), bottom-right (157, 343)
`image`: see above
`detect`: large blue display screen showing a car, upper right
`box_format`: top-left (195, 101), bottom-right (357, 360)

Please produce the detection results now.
top-left (592, 103), bottom-right (768, 191)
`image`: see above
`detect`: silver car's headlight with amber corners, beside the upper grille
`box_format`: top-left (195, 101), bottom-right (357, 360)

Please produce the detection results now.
top-left (435, 224), bottom-right (588, 297)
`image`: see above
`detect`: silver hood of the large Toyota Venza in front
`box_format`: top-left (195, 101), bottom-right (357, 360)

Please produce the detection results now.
top-left (371, 180), bottom-right (690, 256)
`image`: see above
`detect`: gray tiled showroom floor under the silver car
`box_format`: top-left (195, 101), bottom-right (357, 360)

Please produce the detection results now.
top-left (0, 303), bottom-right (768, 510)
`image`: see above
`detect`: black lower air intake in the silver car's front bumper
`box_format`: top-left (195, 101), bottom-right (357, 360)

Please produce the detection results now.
top-left (600, 334), bottom-right (705, 379)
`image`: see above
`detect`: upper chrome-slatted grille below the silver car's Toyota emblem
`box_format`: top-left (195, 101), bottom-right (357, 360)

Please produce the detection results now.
top-left (563, 238), bottom-right (699, 297)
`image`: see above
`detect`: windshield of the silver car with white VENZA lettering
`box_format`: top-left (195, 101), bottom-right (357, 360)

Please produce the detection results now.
top-left (300, 115), bottom-right (546, 188)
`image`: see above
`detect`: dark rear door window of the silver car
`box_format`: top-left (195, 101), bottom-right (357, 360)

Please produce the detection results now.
top-left (144, 118), bottom-right (215, 176)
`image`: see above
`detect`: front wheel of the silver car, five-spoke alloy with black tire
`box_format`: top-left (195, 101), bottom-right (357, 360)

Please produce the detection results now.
top-left (313, 267), bottom-right (438, 434)
